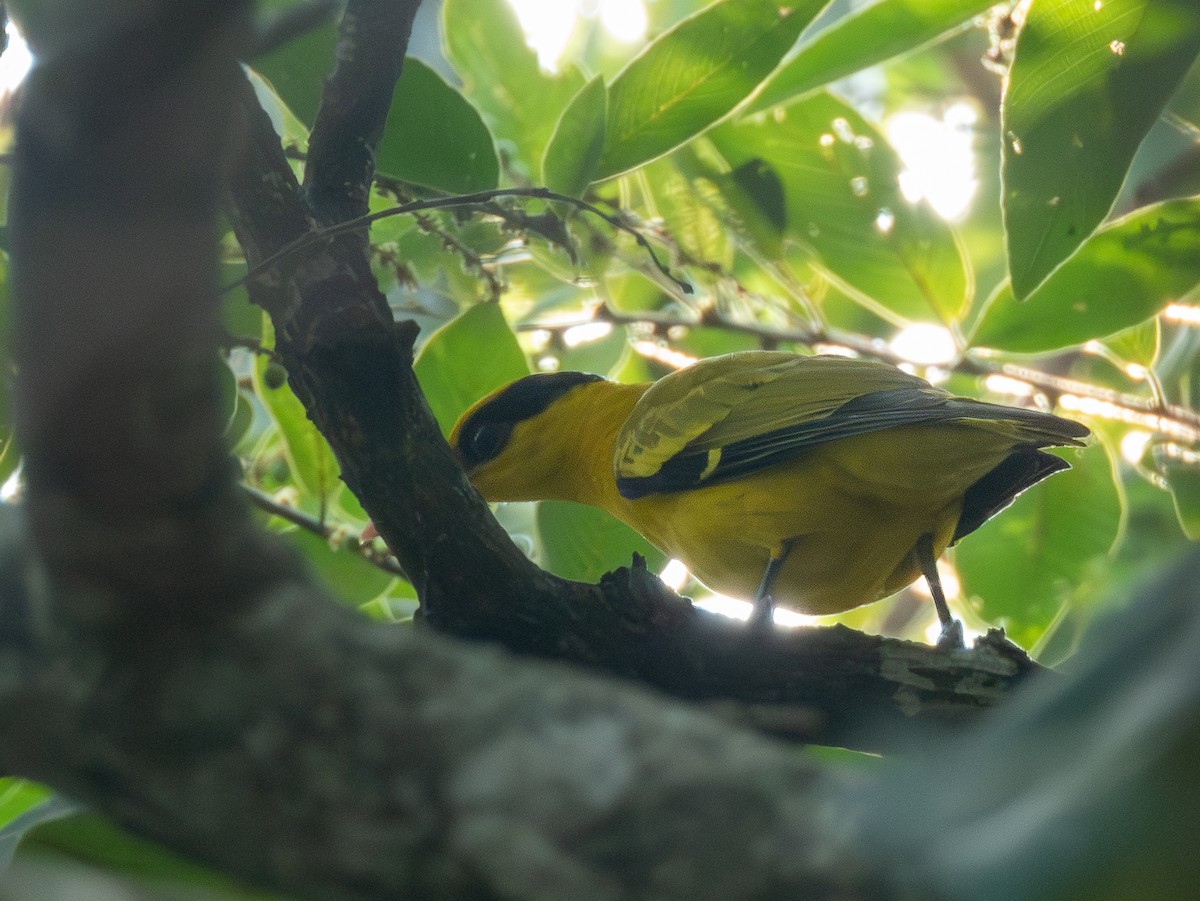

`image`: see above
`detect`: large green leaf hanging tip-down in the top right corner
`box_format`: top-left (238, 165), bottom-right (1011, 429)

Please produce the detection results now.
top-left (1002, 0), bottom-right (1200, 300)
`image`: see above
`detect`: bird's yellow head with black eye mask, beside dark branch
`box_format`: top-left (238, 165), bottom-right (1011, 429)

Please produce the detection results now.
top-left (450, 372), bottom-right (604, 500)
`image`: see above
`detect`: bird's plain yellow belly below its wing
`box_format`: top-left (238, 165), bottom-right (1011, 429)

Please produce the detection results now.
top-left (613, 425), bottom-right (1010, 614)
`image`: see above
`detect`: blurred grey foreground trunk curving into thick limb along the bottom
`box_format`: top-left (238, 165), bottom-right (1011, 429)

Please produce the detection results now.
top-left (7, 7), bottom-right (1200, 901)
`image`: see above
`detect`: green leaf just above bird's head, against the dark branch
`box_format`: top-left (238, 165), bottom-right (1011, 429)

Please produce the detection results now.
top-left (413, 304), bottom-right (529, 434)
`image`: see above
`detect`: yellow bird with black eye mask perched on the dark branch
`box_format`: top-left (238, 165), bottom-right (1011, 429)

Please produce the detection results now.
top-left (450, 352), bottom-right (1088, 642)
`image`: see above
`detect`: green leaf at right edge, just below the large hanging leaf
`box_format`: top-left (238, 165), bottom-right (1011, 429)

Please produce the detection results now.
top-left (971, 197), bottom-right (1200, 353)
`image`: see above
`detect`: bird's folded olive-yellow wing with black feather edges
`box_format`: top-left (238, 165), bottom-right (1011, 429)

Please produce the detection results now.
top-left (613, 352), bottom-right (1087, 498)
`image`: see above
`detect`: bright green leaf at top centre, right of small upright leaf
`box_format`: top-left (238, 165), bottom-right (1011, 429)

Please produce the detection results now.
top-left (598, 0), bottom-right (824, 179)
